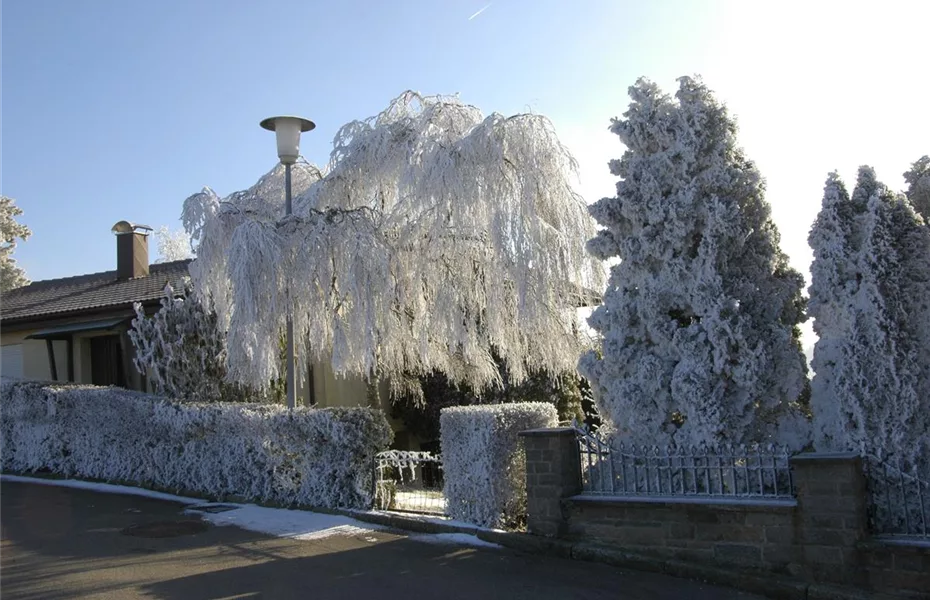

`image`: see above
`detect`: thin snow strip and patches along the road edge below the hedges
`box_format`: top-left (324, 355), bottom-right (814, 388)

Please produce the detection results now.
top-left (0, 475), bottom-right (500, 548)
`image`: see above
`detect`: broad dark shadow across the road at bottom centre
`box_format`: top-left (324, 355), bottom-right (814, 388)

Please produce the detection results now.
top-left (141, 539), bottom-right (758, 600)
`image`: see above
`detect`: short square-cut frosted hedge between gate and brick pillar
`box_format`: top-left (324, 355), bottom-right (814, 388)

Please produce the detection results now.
top-left (439, 402), bottom-right (559, 527)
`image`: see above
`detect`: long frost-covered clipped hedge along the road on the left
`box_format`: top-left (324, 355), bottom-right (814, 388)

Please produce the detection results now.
top-left (0, 379), bottom-right (391, 508)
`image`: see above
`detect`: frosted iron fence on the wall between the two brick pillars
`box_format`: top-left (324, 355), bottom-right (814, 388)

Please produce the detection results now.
top-left (576, 428), bottom-right (794, 499)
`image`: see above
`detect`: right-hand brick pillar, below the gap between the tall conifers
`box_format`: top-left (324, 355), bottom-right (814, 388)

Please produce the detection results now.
top-left (791, 453), bottom-right (868, 585)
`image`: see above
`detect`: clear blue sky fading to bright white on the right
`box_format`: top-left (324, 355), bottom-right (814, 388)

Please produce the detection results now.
top-left (0, 0), bottom-right (930, 280)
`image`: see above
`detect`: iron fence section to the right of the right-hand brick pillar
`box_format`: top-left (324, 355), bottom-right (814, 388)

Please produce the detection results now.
top-left (863, 454), bottom-right (930, 540)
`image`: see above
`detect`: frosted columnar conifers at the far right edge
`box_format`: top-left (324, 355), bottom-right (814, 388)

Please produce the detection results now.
top-left (809, 167), bottom-right (930, 466)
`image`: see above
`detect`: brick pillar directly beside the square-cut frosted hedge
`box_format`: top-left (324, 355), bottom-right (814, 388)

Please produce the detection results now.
top-left (520, 427), bottom-right (581, 536)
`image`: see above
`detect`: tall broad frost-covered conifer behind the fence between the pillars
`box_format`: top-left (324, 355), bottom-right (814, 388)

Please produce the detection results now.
top-left (579, 77), bottom-right (809, 445)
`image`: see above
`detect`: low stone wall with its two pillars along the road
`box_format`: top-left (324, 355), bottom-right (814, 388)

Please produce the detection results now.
top-left (523, 428), bottom-right (930, 598)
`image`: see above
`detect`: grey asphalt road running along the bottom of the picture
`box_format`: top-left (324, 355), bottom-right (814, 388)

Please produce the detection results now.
top-left (0, 482), bottom-right (760, 600)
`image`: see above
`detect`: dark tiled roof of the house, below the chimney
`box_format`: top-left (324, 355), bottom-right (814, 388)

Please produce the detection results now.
top-left (0, 259), bottom-right (191, 325)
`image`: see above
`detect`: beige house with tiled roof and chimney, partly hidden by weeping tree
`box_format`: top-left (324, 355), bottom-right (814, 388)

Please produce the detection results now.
top-left (0, 221), bottom-right (396, 420)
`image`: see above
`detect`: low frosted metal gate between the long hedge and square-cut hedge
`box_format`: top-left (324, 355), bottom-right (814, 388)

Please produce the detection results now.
top-left (374, 450), bottom-right (446, 515)
